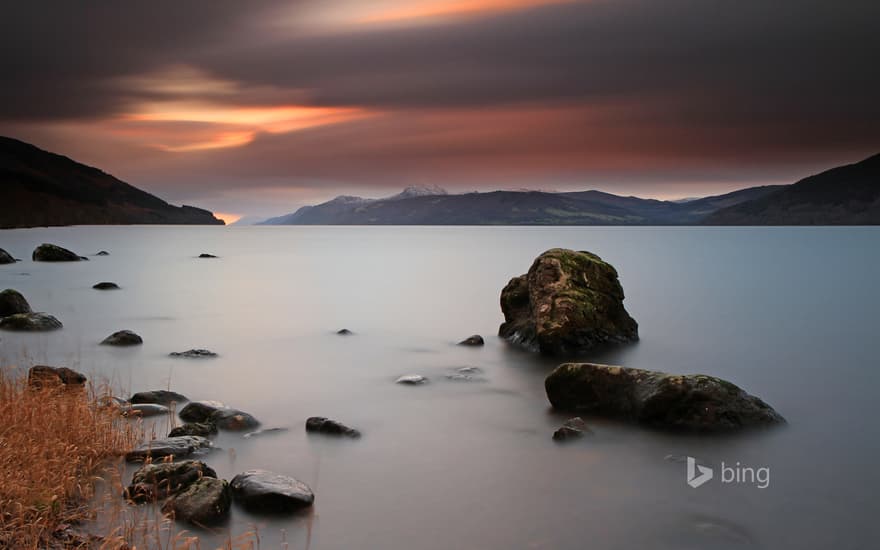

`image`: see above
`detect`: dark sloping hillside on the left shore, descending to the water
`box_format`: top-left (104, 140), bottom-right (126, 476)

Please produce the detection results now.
top-left (0, 136), bottom-right (223, 229)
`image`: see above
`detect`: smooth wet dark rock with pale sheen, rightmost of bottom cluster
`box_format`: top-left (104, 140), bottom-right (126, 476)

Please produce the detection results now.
top-left (230, 470), bottom-right (315, 512)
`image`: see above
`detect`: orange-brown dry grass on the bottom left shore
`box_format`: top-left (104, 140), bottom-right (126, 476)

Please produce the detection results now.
top-left (0, 370), bottom-right (140, 549)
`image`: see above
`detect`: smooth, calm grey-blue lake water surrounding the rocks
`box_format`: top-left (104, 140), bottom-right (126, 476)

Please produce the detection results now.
top-left (0, 227), bottom-right (880, 550)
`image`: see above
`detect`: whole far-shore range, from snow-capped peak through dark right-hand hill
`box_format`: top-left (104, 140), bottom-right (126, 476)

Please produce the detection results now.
top-left (262, 155), bottom-right (880, 225)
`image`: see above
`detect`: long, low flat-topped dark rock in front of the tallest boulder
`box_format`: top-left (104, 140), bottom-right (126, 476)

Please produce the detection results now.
top-left (544, 363), bottom-right (785, 431)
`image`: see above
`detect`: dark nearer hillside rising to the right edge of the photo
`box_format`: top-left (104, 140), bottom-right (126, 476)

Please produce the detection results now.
top-left (704, 154), bottom-right (880, 225)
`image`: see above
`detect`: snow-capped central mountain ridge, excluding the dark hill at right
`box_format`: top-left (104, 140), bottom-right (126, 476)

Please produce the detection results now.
top-left (263, 187), bottom-right (776, 225)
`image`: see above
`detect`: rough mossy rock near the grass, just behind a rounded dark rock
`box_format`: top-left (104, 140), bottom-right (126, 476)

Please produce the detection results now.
top-left (125, 460), bottom-right (217, 502)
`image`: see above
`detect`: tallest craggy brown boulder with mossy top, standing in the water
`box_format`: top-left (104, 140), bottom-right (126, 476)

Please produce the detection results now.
top-left (498, 248), bottom-right (639, 355)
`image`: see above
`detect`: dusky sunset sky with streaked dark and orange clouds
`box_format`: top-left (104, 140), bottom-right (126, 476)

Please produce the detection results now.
top-left (0, 0), bottom-right (880, 221)
